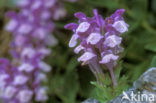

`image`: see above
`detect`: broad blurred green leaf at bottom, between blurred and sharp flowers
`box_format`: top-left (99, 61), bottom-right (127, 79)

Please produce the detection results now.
top-left (50, 71), bottom-right (79, 103)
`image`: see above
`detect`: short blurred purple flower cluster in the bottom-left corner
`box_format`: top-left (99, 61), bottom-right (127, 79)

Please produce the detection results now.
top-left (0, 58), bottom-right (33, 103)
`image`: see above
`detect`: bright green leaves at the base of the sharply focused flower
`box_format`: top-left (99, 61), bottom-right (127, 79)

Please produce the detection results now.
top-left (91, 67), bottom-right (128, 103)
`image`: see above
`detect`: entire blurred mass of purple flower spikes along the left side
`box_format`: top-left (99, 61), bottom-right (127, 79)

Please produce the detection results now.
top-left (0, 0), bottom-right (65, 103)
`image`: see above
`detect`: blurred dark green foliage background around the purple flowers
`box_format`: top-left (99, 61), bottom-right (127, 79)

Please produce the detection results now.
top-left (0, 0), bottom-right (156, 103)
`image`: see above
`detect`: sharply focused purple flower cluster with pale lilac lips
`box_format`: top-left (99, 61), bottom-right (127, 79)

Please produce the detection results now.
top-left (65, 9), bottom-right (128, 85)
